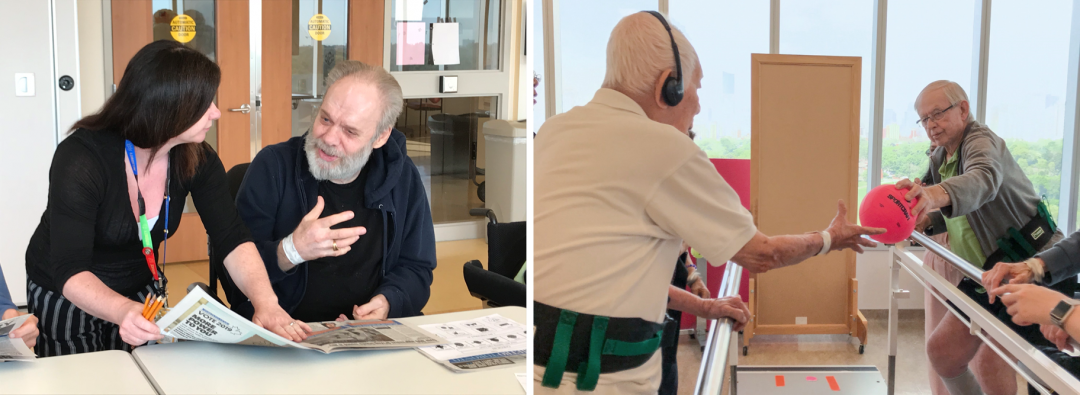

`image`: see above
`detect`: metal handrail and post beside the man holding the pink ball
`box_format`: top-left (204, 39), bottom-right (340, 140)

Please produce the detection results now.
top-left (889, 232), bottom-right (1080, 395)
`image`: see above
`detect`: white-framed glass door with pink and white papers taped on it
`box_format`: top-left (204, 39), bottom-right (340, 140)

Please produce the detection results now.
top-left (383, 0), bottom-right (511, 228)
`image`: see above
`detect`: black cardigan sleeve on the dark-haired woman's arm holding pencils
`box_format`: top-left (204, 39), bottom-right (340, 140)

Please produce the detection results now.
top-left (44, 138), bottom-right (107, 292)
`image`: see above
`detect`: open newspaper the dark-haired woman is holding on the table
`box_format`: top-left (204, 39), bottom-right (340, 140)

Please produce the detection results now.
top-left (157, 288), bottom-right (445, 353)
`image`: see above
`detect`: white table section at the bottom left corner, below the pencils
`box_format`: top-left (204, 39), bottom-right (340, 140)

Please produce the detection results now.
top-left (0, 351), bottom-right (154, 394)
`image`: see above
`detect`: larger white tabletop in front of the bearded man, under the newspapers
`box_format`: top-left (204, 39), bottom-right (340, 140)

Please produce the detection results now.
top-left (132, 307), bottom-right (528, 394)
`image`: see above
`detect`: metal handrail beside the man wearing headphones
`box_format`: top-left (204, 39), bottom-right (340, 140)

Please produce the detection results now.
top-left (693, 261), bottom-right (748, 395)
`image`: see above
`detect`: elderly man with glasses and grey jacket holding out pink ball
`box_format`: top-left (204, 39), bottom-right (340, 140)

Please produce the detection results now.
top-left (896, 81), bottom-right (1076, 394)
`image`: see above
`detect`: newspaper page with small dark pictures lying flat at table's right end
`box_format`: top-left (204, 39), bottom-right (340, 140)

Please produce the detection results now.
top-left (417, 314), bottom-right (528, 372)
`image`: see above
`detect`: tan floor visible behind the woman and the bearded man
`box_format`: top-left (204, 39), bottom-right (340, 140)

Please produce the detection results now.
top-left (165, 239), bottom-right (487, 314)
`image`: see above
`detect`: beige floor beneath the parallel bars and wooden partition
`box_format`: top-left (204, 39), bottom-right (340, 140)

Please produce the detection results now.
top-left (678, 310), bottom-right (1027, 395)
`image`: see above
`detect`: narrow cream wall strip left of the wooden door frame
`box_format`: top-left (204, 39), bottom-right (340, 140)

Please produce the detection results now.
top-left (76, 0), bottom-right (105, 117)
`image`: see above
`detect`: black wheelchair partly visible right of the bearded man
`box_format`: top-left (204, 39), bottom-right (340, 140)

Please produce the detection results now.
top-left (462, 208), bottom-right (531, 308)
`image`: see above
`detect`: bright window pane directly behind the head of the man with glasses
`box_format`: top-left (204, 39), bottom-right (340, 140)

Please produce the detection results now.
top-left (881, 0), bottom-right (976, 187)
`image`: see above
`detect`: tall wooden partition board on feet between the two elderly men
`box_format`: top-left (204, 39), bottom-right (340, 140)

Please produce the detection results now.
top-left (743, 54), bottom-right (866, 353)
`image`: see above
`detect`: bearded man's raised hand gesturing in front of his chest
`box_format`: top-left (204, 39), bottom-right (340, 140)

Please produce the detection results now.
top-left (293, 196), bottom-right (367, 261)
